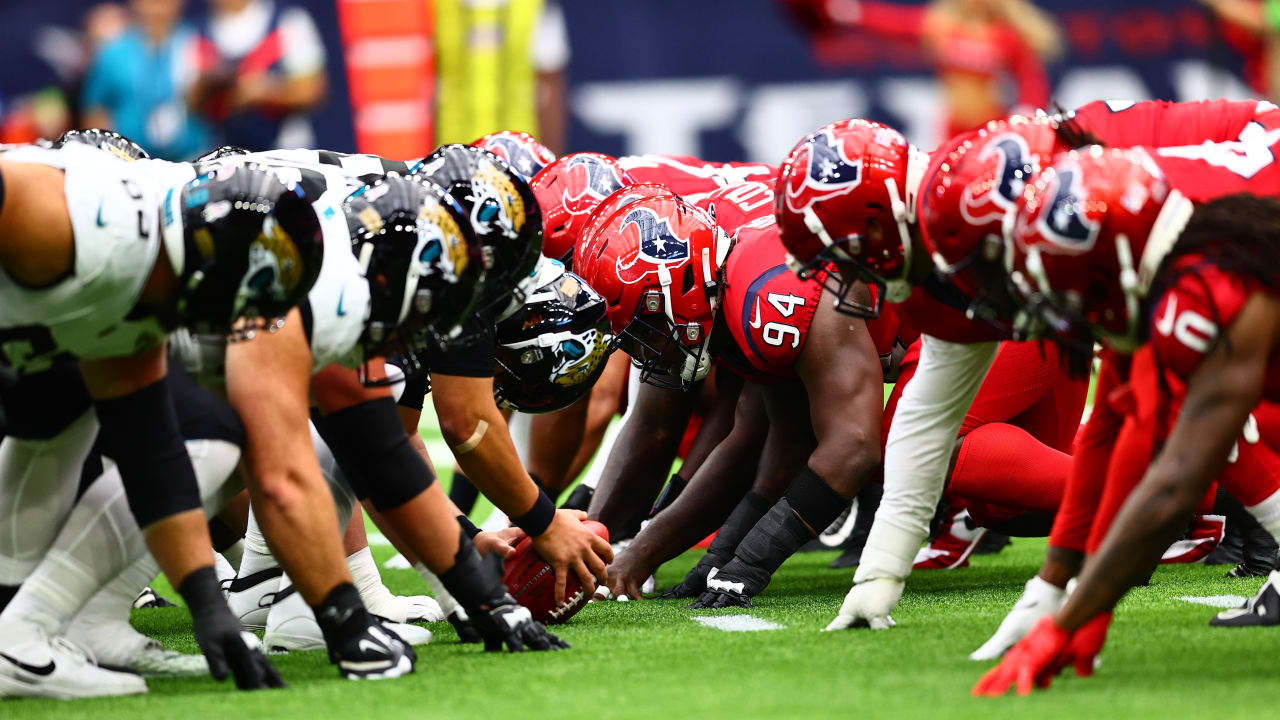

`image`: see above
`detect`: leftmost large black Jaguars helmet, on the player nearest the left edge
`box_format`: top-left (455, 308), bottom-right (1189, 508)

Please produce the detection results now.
top-left (164, 165), bottom-right (324, 337)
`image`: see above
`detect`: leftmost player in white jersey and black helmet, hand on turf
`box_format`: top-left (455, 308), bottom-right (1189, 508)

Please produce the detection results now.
top-left (0, 142), bottom-right (309, 697)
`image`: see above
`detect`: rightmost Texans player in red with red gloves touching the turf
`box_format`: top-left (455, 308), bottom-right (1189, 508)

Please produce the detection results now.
top-left (974, 144), bottom-right (1280, 694)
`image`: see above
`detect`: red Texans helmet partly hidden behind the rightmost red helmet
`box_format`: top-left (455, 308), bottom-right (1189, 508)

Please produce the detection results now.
top-left (918, 115), bottom-right (1066, 320)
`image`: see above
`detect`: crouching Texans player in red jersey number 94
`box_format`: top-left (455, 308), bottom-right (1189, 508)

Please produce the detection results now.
top-left (575, 183), bottom-right (893, 607)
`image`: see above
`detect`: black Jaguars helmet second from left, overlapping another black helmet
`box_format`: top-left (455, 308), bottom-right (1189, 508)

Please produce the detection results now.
top-left (342, 173), bottom-right (483, 374)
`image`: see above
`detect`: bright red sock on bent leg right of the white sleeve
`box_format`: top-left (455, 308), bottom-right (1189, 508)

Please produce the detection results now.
top-left (947, 423), bottom-right (1071, 512)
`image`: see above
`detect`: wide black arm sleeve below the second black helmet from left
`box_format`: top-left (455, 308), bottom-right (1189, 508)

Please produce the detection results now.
top-left (316, 397), bottom-right (435, 512)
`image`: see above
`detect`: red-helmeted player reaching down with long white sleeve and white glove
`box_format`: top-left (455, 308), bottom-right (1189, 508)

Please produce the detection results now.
top-left (780, 101), bottom-right (1280, 629)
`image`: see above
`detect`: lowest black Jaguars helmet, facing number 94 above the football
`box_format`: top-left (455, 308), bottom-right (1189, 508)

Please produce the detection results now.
top-left (493, 260), bottom-right (613, 413)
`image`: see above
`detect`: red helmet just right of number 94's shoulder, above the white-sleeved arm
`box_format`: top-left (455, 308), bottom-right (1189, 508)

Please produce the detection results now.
top-left (774, 119), bottom-right (928, 318)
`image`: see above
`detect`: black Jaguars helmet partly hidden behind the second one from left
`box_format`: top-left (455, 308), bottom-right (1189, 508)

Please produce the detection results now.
top-left (412, 145), bottom-right (543, 333)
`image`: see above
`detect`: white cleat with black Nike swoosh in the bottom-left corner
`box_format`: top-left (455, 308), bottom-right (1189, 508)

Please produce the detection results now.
top-left (0, 620), bottom-right (147, 700)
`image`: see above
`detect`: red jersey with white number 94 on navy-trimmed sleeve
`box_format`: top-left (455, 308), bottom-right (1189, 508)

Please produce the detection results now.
top-left (698, 182), bottom-right (900, 384)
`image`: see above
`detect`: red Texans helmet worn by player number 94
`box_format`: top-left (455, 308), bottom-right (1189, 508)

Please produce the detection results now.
top-left (584, 197), bottom-right (732, 389)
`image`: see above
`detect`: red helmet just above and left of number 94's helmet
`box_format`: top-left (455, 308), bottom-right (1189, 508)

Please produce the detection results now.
top-left (530, 152), bottom-right (635, 264)
